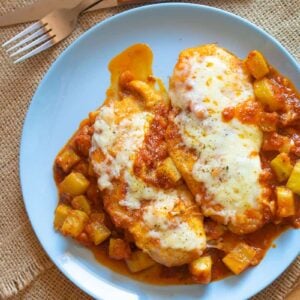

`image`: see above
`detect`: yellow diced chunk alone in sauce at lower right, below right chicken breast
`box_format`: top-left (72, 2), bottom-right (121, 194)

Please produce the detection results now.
top-left (222, 243), bottom-right (256, 275)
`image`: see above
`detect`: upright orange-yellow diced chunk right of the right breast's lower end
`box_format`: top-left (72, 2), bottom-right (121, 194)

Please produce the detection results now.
top-left (276, 186), bottom-right (295, 218)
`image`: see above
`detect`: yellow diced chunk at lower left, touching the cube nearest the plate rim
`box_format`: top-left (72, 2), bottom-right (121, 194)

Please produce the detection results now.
top-left (61, 210), bottom-right (89, 238)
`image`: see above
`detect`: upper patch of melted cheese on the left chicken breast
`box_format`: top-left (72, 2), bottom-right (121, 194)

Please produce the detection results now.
top-left (91, 106), bottom-right (153, 192)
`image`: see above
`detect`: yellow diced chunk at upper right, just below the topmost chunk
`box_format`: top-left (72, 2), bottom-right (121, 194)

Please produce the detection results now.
top-left (253, 78), bottom-right (281, 111)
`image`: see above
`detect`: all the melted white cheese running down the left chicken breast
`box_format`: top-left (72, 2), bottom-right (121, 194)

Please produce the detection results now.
top-left (91, 106), bottom-right (205, 250)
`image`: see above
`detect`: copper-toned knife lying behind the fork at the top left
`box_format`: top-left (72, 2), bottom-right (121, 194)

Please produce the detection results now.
top-left (0, 0), bottom-right (163, 27)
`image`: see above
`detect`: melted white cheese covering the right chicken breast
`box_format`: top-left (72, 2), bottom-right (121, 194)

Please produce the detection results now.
top-left (170, 49), bottom-right (262, 223)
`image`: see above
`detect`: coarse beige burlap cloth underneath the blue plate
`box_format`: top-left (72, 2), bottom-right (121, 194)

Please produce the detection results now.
top-left (0, 0), bottom-right (300, 300)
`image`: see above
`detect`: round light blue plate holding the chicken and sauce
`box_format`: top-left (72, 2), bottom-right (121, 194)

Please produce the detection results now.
top-left (20, 4), bottom-right (300, 300)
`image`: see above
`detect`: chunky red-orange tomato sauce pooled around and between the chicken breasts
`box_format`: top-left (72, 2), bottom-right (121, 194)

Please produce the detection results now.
top-left (54, 47), bottom-right (300, 285)
